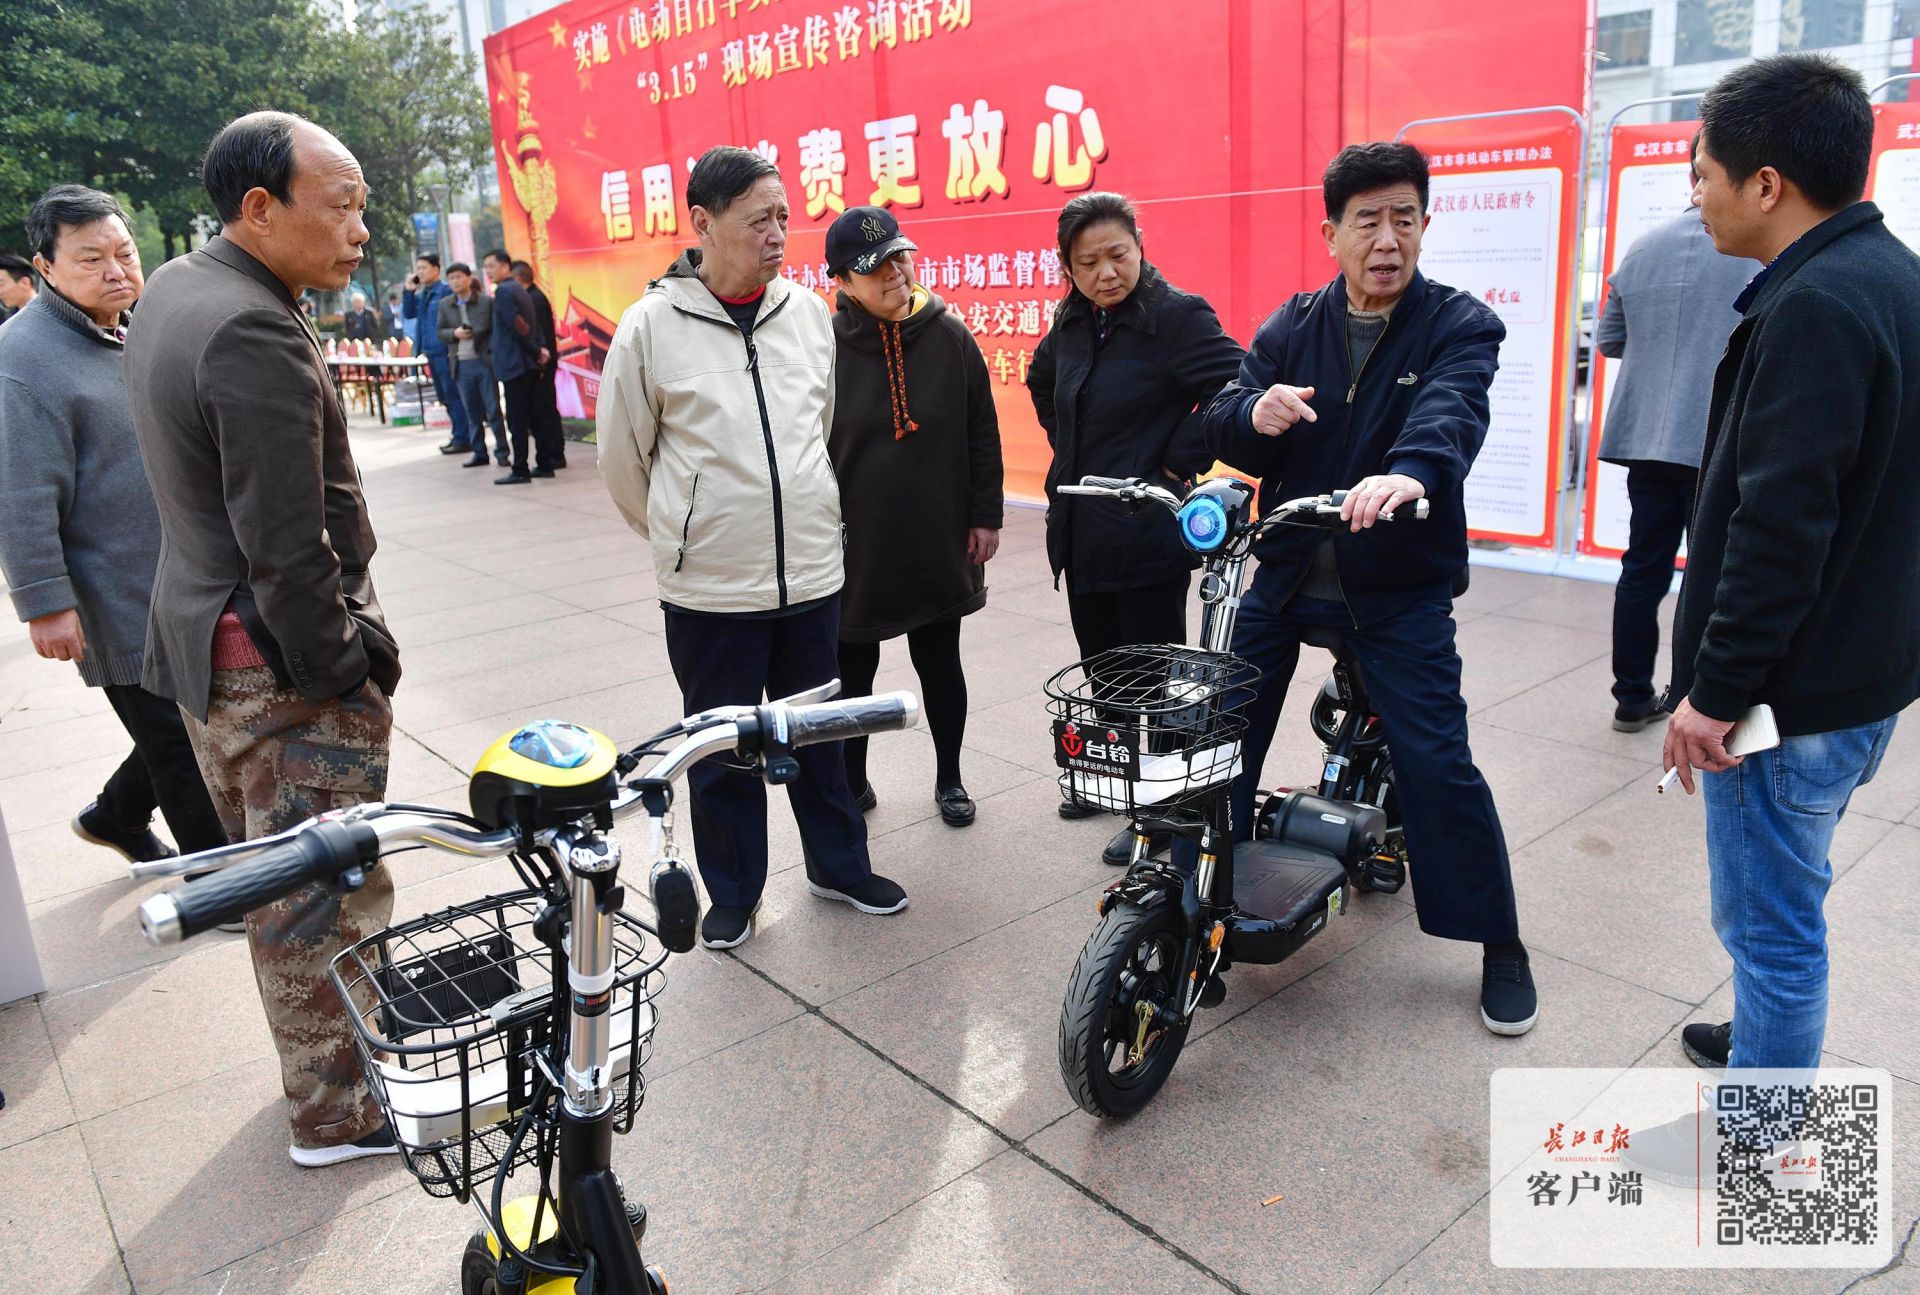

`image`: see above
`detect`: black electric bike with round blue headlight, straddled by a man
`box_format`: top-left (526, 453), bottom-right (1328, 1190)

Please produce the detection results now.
top-left (1046, 468), bottom-right (1427, 1116)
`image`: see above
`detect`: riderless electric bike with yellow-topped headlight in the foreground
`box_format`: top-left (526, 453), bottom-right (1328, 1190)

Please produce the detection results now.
top-left (134, 680), bottom-right (918, 1295)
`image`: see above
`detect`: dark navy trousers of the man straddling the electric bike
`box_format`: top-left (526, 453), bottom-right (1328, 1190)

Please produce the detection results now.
top-left (1233, 567), bottom-right (1519, 943)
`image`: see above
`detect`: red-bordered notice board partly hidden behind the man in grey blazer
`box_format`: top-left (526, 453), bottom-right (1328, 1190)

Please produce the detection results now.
top-left (1580, 121), bottom-right (1699, 557)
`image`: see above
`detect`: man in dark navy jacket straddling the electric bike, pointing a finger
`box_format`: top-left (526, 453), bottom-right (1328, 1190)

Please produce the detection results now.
top-left (1206, 144), bottom-right (1538, 1034)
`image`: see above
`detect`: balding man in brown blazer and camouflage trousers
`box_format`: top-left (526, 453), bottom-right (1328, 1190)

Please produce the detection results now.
top-left (127, 111), bottom-right (399, 1166)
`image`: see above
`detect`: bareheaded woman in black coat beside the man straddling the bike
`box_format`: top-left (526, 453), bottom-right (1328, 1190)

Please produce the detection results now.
top-left (1027, 194), bottom-right (1246, 841)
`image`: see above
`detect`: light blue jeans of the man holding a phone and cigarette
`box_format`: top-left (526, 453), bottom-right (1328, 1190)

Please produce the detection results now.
top-left (1701, 717), bottom-right (1893, 1070)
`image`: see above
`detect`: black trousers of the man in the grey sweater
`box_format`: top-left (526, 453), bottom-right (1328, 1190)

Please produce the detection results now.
top-left (94, 684), bottom-right (227, 855)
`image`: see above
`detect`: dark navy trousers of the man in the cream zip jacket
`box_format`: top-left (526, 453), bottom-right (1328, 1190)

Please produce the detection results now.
top-left (666, 594), bottom-right (872, 909)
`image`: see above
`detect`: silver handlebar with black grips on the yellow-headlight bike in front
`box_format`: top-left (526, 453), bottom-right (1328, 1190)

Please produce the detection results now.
top-left (132, 692), bottom-right (920, 943)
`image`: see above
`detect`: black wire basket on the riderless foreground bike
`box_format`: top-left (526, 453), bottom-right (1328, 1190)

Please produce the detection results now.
top-left (332, 890), bottom-right (666, 1201)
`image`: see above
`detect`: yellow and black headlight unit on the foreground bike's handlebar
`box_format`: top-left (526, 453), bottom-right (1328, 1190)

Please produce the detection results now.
top-left (467, 719), bottom-right (620, 834)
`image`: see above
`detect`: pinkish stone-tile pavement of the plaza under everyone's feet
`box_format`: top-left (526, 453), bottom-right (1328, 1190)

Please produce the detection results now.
top-left (0, 416), bottom-right (1920, 1295)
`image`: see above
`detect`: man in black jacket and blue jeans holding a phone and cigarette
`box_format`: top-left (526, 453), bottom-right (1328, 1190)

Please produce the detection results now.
top-left (1663, 54), bottom-right (1920, 1068)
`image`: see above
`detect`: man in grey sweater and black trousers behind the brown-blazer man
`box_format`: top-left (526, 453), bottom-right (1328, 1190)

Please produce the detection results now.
top-left (0, 184), bottom-right (227, 861)
